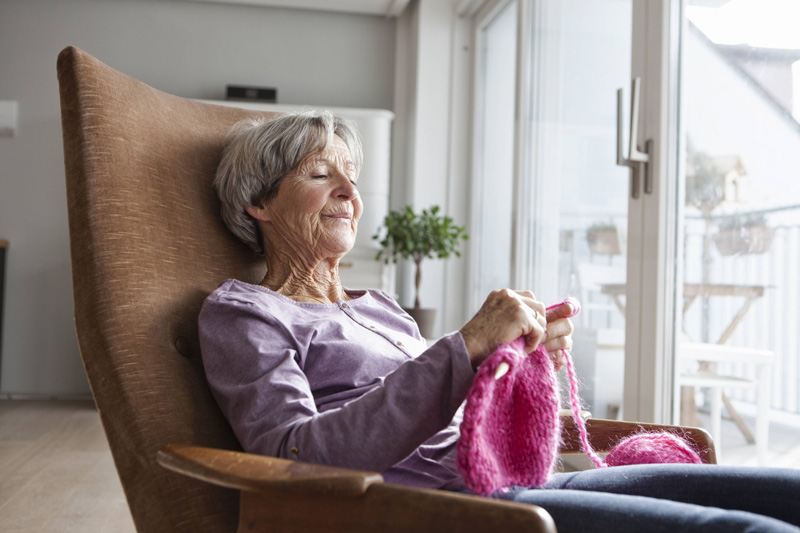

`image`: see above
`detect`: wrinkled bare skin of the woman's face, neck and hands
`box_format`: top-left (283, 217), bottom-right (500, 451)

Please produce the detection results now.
top-left (247, 136), bottom-right (573, 369)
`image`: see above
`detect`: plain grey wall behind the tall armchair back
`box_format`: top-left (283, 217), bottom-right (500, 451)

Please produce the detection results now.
top-left (0, 0), bottom-right (395, 395)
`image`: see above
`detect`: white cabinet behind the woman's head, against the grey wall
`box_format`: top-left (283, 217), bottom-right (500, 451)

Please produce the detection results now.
top-left (202, 100), bottom-right (395, 296)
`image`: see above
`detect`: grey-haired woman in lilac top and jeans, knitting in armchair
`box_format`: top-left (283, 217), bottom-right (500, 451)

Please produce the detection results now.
top-left (199, 112), bottom-right (800, 531)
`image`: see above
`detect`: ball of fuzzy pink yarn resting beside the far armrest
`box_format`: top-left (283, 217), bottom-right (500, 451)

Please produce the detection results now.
top-left (606, 433), bottom-right (703, 466)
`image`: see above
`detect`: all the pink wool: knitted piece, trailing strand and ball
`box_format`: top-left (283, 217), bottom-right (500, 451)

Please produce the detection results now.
top-left (457, 298), bottom-right (702, 496)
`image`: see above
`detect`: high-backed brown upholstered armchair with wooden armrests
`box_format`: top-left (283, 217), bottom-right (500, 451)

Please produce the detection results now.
top-left (58, 47), bottom-right (714, 532)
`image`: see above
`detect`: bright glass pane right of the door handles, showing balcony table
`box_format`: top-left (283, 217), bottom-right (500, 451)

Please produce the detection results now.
top-left (675, 0), bottom-right (800, 466)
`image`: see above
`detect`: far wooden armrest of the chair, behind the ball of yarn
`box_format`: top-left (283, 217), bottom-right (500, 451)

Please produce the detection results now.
top-left (561, 415), bottom-right (717, 464)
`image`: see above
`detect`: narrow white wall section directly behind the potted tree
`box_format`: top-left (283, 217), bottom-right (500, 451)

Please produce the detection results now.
top-left (390, 0), bottom-right (471, 336)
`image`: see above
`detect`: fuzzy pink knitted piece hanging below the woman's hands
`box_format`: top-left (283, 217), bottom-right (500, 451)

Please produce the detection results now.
top-left (457, 337), bottom-right (560, 496)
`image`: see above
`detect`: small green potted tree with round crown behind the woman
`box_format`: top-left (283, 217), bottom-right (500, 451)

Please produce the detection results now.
top-left (372, 205), bottom-right (467, 338)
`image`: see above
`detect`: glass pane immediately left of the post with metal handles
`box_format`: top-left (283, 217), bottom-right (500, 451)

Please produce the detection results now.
top-left (515, 0), bottom-right (632, 424)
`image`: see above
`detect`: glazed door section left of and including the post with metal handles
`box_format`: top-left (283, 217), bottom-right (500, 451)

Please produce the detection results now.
top-left (471, 0), bottom-right (680, 422)
